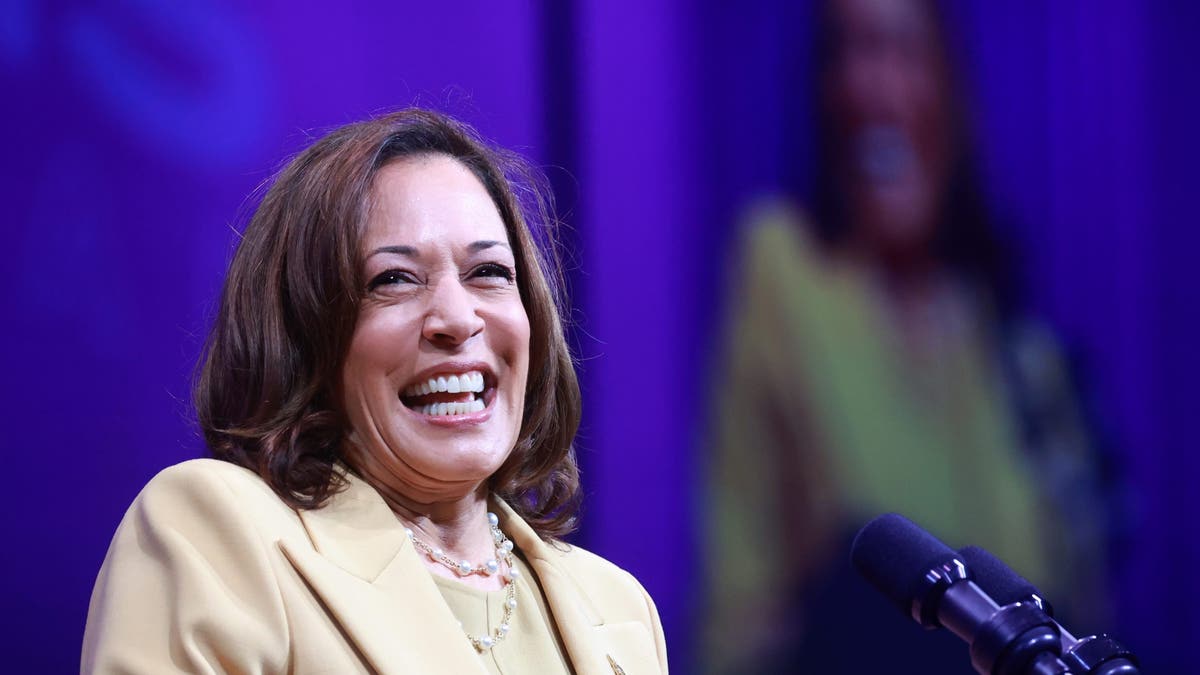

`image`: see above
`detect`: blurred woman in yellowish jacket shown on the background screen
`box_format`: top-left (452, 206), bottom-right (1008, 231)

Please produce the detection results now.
top-left (703, 0), bottom-right (1105, 673)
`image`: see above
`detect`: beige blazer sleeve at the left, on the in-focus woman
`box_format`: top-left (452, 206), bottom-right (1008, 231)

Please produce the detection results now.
top-left (80, 460), bottom-right (289, 674)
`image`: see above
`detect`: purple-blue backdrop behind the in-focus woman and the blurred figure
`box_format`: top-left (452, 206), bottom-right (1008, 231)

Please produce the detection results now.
top-left (0, 0), bottom-right (1200, 673)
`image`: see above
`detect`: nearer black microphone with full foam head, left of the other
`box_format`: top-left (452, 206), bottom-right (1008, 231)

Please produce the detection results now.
top-left (851, 513), bottom-right (1069, 675)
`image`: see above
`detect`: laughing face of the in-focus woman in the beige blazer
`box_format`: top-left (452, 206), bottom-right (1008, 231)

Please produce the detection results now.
top-left (342, 155), bottom-right (529, 502)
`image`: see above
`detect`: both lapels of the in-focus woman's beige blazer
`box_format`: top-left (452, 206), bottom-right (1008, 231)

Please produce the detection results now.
top-left (278, 471), bottom-right (612, 675)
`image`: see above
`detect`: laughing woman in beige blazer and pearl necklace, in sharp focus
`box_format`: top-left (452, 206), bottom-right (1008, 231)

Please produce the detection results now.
top-left (82, 109), bottom-right (667, 673)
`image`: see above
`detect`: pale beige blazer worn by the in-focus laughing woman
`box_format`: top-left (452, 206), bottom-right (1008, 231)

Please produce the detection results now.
top-left (80, 460), bottom-right (667, 675)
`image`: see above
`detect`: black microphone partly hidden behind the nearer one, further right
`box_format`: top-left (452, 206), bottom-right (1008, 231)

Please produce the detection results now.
top-left (959, 546), bottom-right (1140, 675)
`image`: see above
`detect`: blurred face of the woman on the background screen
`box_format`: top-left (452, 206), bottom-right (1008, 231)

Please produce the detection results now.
top-left (824, 0), bottom-right (952, 250)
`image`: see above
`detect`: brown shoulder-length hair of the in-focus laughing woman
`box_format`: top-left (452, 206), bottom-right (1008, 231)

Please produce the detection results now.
top-left (194, 108), bottom-right (581, 538)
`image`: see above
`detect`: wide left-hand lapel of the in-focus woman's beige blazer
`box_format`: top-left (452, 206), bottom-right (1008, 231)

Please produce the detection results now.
top-left (278, 474), bottom-right (486, 674)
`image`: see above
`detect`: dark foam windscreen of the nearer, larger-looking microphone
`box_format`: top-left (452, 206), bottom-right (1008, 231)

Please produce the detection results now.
top-left (850, 513), bottom-right (955, 615)
